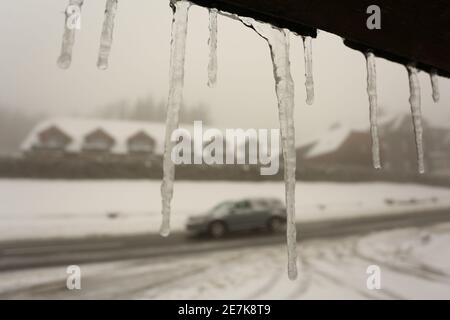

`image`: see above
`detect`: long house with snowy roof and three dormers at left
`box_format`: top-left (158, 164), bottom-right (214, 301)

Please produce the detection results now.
top-left (21, 118), bottom-right (202, 161)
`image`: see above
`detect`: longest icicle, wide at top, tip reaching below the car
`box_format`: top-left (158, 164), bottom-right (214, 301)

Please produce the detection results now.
top-left (240, 18), bottom-right (297, 280)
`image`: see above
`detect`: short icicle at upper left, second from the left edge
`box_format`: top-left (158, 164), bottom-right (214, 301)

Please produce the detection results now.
top-left (97, 0), bottom-right (118, 70)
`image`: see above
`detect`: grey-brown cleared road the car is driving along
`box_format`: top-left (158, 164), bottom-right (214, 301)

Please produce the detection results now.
top-left (0, 209), bottom-right (450, 272)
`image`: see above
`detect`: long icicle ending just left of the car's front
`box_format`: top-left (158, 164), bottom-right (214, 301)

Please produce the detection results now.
top-left (160, 0), bottom-right (190, 237)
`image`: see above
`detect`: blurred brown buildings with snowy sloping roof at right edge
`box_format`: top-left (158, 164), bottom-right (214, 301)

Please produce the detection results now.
top-left (297, 114), bottom-right (450, 173)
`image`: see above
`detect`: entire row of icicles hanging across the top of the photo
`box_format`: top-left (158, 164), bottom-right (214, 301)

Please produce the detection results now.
top-left (58, 0), bottom-right (439, 280)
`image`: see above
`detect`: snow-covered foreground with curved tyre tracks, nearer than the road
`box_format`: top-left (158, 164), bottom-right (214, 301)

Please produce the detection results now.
top-left (0, 224), bottom-right (450, 299)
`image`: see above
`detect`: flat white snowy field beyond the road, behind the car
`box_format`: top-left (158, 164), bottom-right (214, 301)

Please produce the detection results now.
top-left (0, 179), bottom-right (450, 240)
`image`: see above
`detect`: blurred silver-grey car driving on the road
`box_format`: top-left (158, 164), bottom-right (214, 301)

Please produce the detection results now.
top-left (186, 198), bottom-right (286, 238)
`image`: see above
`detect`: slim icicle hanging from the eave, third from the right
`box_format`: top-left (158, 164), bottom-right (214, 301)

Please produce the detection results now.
top-left (365, 51), bottom-right (381, 169)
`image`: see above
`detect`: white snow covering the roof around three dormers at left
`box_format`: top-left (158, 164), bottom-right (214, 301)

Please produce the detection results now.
top-left (20, 118), bottom-right (197, 154)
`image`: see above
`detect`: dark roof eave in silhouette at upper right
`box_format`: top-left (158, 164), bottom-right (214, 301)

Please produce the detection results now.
top-left (191, 0), bottom-right (450, 77)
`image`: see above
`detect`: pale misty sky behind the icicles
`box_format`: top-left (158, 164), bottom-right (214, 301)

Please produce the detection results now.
top-left (0, 0), bottom-right (450, 140)
